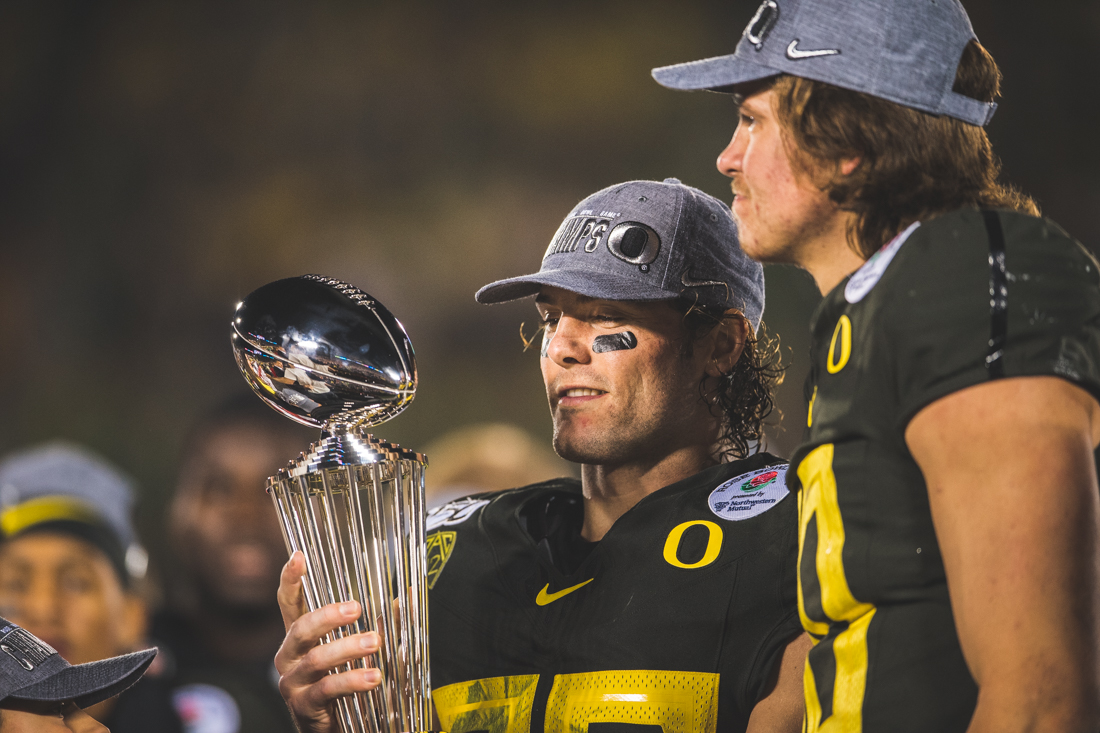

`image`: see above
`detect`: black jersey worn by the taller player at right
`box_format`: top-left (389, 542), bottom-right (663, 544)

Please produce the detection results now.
top-left (788, 209), bottom-right (1100, 733)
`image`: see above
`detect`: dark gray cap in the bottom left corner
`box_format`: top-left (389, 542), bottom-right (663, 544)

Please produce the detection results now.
top-left (0, 619), bottom-right (156, 708)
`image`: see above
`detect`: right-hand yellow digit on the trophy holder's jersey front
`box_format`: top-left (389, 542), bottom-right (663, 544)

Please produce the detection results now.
top-left (543, 669), bottom-right (718, 733)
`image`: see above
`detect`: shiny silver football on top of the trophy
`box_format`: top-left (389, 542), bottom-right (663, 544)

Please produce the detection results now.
top-left (232, 275), bottom-right (417, 427)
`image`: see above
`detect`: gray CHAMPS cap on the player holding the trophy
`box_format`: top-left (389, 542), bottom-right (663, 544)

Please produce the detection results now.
top-left (474, 178), bottom-right (763, 330)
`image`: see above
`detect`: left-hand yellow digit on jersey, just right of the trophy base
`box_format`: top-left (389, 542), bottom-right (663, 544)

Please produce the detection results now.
top-left (431, 675), bottom-right (539, 733)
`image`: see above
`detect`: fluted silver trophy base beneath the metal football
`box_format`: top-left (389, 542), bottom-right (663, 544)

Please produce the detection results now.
top-left (267, 428), bottom-right (431, 733)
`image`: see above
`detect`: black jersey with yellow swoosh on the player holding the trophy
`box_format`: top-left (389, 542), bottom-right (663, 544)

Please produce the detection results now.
top-left (428, 453), bottom-right (802, 733)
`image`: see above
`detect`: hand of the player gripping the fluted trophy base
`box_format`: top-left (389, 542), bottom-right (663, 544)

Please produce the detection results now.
top-left (275, 553), bottom-right (382, 733)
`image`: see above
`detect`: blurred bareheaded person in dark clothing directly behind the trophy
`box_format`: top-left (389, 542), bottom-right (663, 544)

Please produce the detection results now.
top-left (153, 394), bottom-right (317, 733)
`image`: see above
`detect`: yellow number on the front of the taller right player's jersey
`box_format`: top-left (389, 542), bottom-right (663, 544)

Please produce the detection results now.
top-left (798, 444), bottom-right (875, 733)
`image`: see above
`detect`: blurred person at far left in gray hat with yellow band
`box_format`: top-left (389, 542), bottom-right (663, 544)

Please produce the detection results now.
top-left (0, 442), bottom-right (183, 733)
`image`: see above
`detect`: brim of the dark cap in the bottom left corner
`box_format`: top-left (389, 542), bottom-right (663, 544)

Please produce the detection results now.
top-left (8, 649), bottom-right (156, 708)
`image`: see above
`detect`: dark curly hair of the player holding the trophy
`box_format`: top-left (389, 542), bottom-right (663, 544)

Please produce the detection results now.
top-left (673, 298), bottom-right (787, 461)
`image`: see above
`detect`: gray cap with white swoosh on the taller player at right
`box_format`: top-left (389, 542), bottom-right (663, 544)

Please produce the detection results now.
top-left (653, 0), bottom-right (997, 125)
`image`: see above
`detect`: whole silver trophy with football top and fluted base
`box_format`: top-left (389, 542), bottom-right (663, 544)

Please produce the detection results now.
top-left (232, 275), bottom-right (431, 733)
